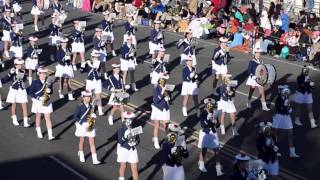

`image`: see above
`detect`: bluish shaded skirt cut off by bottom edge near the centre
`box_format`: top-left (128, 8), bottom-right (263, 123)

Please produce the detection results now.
top-left (162, 165), bottom-right (185, 180)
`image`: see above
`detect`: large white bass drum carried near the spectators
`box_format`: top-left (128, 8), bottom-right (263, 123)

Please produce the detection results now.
top-left (255, 64), bottom-right (277, 86)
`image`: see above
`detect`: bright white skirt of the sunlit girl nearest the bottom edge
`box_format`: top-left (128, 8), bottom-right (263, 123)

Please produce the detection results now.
top-left (117, 146), bottom-right (139, 163)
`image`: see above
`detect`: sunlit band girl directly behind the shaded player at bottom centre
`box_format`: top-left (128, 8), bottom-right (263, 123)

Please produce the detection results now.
top-left (151, 74), bottom-right (170, 149)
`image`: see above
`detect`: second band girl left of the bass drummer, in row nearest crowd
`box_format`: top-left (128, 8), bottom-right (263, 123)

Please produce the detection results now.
top-left (178, 29), bottom-right (197, 67)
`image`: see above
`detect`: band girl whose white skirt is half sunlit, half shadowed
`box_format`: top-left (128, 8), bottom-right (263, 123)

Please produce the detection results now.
top-left (198, 98), bottom-right (223, 176)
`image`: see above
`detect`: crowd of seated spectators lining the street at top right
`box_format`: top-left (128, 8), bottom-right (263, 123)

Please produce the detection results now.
top-left (70, 0), bottom-right (320, 67)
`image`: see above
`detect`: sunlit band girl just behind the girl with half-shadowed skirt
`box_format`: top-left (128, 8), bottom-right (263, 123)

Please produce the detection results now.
top-left (217, 74), bottom-right (239, 136)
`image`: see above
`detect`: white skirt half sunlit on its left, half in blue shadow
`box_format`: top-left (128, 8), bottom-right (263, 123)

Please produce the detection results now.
top-left (198, 129), bottom-right (219, 149)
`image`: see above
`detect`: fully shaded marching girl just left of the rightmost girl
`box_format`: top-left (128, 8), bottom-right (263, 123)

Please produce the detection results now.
top-left (272, 85), bottom-right (300, 158)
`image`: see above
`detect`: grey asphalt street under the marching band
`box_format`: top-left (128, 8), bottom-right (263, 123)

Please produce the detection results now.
top-left (0, 1), bottom-right (320, 180)
